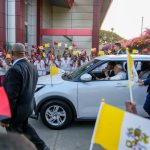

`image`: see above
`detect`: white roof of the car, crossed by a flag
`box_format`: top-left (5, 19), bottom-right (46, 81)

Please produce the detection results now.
top-left (94, 54), bottom-right (150, 61)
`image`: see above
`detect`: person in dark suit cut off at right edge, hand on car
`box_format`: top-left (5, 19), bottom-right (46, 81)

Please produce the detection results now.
top-left (138, 75), bottom-right (150, 116)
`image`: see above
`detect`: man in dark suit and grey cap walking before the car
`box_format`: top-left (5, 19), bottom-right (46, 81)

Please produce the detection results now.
top-left (1, 43), bottom-right (49, 150)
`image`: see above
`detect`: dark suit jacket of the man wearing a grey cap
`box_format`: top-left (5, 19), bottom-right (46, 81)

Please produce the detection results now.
top-left (4, 59), bottom-right (38, 124)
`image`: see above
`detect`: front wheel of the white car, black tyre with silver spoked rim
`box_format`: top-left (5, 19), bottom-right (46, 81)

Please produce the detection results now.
top-left (40, 100), bottom-right (72, 130)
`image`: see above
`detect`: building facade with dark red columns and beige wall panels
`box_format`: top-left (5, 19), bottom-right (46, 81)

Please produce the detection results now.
top-left (0, 0), bottom-right (112, 53)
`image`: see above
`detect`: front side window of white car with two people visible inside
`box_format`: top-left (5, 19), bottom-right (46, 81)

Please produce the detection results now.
top-left (89, 61), bottom-right (127, 81)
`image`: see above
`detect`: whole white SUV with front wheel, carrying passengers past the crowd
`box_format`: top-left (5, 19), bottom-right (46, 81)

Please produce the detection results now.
top-left (35, 55), bottom-right (150, 129)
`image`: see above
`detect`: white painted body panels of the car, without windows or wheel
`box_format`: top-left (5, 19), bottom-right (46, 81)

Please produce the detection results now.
top-left (35, 55), bottom-right (150, 119)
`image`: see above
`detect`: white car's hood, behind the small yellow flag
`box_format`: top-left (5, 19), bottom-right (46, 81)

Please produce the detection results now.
top-left (37, 71), bottom-right (64, 85)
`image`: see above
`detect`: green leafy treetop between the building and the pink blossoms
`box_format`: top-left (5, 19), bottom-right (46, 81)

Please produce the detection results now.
top-left (99, 30), bottom-right (124, 45)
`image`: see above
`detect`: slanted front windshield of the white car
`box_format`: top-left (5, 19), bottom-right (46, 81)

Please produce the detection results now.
top-left (70, 59), bottom-right (99, 79)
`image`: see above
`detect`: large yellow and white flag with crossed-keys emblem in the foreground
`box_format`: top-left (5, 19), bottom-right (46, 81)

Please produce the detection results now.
top-left (90, 103), bottom-right (150, 150)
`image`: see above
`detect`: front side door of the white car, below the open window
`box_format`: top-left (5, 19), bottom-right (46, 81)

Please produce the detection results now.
top-left (78, 60), bottom-right (129, 118)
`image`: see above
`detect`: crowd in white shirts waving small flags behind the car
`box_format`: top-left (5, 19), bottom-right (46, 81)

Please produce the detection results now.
top-left (0, 43), bottom-right (149, 85)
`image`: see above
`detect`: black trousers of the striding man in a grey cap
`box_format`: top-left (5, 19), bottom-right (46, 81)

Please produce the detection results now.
top-left (6, 120), bottom-right (46, 150)
